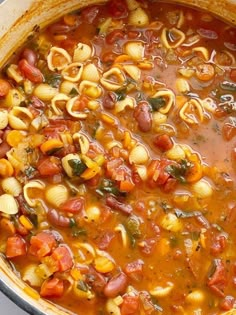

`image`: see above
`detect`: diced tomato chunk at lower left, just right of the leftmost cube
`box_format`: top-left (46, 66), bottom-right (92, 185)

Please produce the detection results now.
top-left (29, 232), bottom-right (57, 258)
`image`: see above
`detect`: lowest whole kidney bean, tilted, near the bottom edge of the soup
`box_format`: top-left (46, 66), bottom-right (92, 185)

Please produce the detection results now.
top-left (103, 272), bottom-right (128, 298)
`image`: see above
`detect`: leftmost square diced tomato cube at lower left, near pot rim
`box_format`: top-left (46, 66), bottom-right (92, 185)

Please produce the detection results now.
top-left (6, 235), bottom-right (26, 258)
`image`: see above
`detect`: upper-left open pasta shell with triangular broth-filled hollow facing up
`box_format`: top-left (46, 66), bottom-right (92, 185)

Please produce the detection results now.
top-left (47, 47), bottom-right (72, 71)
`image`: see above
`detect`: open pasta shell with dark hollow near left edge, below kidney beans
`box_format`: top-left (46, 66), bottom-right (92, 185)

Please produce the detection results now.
top-left (8, 106), bottom-right (33, 130)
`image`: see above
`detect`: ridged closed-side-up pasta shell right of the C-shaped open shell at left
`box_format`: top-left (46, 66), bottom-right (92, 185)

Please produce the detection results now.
top-left (45, 185), bottom-right (69, 207)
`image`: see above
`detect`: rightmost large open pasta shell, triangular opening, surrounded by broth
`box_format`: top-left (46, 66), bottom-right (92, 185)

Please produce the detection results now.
top-left (179, 99), bottom-right (204, 125)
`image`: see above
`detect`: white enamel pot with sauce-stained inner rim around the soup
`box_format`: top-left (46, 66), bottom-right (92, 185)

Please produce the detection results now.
top-left (0, 0), bottom-right (236, 315)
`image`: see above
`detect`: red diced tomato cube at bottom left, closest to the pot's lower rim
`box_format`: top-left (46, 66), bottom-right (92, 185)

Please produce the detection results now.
top-left (40, 278), bottom-right (64, 298)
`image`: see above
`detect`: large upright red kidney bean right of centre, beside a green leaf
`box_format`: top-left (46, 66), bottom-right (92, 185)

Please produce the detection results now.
top-left (134, 102), bottom-right (152, 132)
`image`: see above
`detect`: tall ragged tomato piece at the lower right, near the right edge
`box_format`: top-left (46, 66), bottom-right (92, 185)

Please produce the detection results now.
top-left (207, 259), bottom-right (227, 297)
